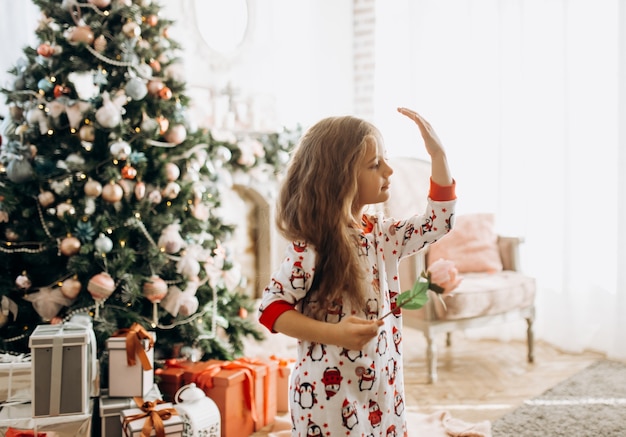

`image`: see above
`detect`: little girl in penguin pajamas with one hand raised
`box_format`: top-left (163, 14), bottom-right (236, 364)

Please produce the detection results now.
top-left (259, 108), bottom-right (456, 437)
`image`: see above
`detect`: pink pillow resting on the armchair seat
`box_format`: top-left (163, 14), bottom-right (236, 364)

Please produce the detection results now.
top-left (428, 213), bottom-right (502, 273)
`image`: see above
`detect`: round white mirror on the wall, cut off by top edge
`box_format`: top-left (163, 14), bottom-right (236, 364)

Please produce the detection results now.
top-left (195, 0), bottom-right (249, 56)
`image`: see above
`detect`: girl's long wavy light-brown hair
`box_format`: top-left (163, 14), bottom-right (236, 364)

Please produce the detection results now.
top-left (276, 116), bottom-right (377, 318)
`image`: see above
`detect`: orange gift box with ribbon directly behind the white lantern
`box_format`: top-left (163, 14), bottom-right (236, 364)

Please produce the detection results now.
top-left (177, 360), bottom-right (256, 437)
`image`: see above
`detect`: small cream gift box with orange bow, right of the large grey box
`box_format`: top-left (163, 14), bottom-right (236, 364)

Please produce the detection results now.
top-left (106, 325), bottom-right (155, 398)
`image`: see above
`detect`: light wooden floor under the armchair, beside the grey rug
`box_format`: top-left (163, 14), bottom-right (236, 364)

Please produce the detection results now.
top-left (253, 327), bottom-right (603, 437)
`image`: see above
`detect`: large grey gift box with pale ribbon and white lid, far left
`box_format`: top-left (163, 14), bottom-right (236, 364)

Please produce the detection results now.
top-left (29, 321), bottom-right (98, 417)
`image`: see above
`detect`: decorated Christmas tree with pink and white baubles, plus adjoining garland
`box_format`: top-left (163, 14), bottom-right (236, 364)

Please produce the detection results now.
top-left (0, 0), bottom-right (294, 359)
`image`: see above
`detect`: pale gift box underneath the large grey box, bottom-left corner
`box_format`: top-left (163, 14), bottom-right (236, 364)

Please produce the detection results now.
top-left (0, 400), bottom-right (92, 437)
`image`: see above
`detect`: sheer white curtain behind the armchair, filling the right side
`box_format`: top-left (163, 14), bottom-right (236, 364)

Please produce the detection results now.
top-left (375, 0), bottom-right (626, 358)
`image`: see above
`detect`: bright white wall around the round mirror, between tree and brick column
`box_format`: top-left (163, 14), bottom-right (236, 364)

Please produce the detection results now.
top-left (163, 0), bottom-right (354, 128)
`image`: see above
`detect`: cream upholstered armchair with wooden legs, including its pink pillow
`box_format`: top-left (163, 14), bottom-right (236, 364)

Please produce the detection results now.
top-left (385, 158), bottom-right (536, 383)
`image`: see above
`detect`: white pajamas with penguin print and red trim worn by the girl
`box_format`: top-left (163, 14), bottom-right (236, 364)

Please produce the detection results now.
top-left (259, 199), bottom-right (455, 437)
